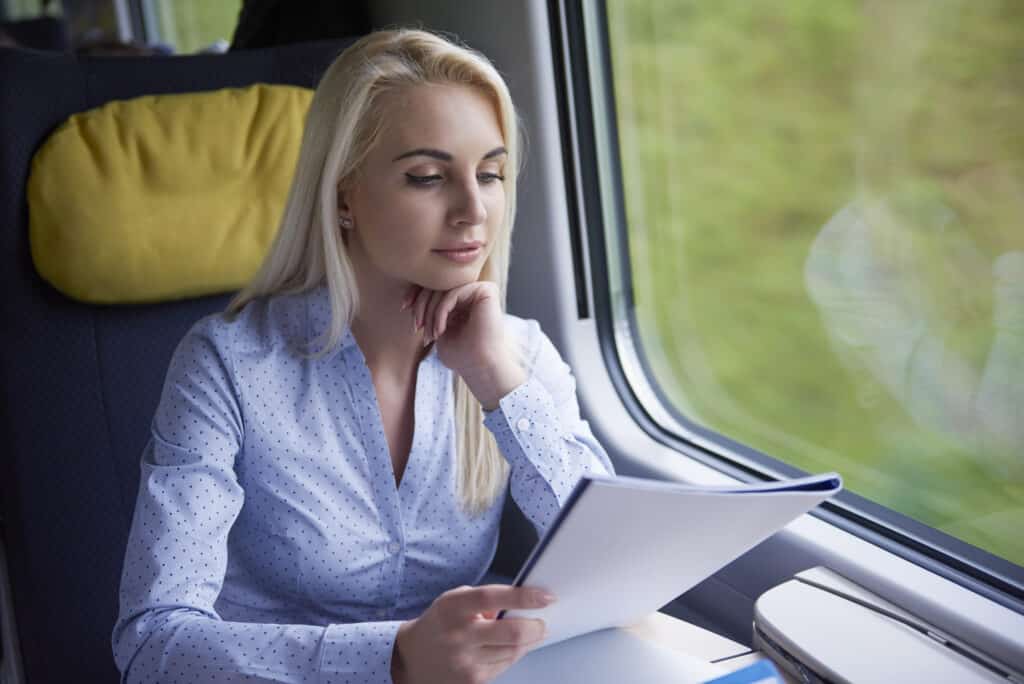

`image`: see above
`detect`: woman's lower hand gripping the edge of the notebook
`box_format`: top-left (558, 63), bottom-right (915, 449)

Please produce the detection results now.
top-left (391, 585), bottom-right (554, 684)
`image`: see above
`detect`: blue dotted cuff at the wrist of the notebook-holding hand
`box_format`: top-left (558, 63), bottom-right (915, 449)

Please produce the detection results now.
top-left (321, 621), bottom-right (401, 684)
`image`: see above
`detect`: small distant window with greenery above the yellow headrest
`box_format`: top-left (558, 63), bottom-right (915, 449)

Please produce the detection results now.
top-left (145, 0), bottom-right (242, 54)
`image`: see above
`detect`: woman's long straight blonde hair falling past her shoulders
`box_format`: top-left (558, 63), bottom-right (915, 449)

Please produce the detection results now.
top-left (226, 29), bottom-right (521, 514)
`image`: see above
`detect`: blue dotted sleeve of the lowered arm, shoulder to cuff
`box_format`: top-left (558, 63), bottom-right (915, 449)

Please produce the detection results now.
top-left (113, 324), bottom-right (400, 683)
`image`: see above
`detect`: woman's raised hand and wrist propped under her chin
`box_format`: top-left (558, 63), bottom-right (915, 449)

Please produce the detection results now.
top-left (406, 281), bottom-right (525, 411)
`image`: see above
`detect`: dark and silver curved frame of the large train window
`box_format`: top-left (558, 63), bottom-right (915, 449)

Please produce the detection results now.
top-left (549, 0), bottom-right (1024, 613)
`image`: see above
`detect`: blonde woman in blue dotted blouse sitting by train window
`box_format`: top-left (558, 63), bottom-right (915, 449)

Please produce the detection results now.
top-left (113, 26), bottom-right (611, 682)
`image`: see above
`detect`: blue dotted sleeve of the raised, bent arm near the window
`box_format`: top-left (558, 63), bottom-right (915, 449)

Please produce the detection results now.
top-left (483, 320), bottom-right (614, 535)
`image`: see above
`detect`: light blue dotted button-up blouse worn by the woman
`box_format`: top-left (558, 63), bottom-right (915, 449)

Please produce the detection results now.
top-left (113, 288), bottom-right (611, 684)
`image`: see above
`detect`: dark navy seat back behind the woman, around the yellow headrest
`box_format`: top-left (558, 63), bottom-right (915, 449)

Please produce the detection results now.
top-left (0, 40), bottom-right (350, 683)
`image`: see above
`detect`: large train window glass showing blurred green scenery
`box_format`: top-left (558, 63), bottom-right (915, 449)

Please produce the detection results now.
top-left (607, 0), bottom-right (1024, 564)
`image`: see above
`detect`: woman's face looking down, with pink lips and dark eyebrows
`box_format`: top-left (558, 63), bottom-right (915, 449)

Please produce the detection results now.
top-left (339, 85), bottom-right (507, 296)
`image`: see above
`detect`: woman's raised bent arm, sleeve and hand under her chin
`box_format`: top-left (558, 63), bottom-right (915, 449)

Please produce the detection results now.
top-left (402, 281), bottom-right (612, 532)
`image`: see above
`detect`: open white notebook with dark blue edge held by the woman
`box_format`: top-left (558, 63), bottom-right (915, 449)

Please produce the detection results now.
top-left (499, 473), bottom-right (843, 647)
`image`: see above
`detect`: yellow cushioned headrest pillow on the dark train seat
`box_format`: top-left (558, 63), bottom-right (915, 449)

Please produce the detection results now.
top-left (28, 85), bottom-right (312, 303)
